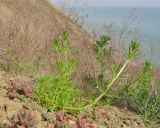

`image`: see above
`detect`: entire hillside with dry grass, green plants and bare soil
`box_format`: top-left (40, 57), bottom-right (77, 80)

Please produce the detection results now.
top-left (0, 0), bottom-right (160, 128)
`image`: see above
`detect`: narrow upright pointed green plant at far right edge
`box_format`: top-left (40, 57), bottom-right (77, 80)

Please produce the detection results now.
top-left (132, 62), bottom-right (160, 120)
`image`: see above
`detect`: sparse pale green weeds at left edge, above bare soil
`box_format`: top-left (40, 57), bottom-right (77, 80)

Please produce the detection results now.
top-left (0, 49), bottom-right (44, 77)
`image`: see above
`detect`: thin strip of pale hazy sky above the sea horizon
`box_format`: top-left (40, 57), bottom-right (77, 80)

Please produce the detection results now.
top-left (51, 0), bottom-right (160, 7)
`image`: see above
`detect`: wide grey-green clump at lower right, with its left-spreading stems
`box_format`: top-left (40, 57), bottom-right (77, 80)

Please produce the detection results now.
top-left (118, 61), bottom-right (160, 122)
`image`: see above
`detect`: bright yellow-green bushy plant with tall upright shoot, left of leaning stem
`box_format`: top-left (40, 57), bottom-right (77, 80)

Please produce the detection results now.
top-left (35, 31), bottom-right (82, 111)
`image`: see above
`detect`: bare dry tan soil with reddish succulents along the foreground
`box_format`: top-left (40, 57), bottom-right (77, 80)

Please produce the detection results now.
top-left (0, 72), bottom-right (160, 128)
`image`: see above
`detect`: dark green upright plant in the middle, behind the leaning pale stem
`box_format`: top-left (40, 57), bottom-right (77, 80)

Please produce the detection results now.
top-left (85, 35), bottom-right (113, 94)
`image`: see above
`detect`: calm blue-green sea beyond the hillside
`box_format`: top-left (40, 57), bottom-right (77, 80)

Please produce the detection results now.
top-left (68, 7), bottom-right (160, 65)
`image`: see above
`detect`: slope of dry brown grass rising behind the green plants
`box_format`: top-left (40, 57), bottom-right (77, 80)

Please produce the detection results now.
top-left (0, 0), bottom-right (93, 82)
